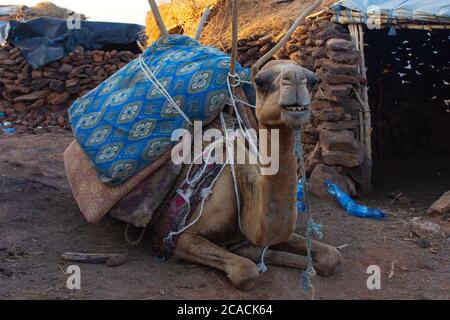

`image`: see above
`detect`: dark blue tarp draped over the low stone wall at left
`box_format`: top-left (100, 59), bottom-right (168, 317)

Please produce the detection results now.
top-left (8, 18), bottom-right (145, 68)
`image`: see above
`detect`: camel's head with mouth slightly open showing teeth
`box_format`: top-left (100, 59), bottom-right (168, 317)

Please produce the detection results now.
top-left (253, 60), bottom-right (318, 129)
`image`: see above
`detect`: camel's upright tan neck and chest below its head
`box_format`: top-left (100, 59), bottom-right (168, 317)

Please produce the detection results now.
top-left (239, 127), bottom-right (297, 246)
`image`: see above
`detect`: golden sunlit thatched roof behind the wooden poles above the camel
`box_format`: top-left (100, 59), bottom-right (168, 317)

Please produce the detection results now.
top-left (147, 0), bottom-right (336, 50)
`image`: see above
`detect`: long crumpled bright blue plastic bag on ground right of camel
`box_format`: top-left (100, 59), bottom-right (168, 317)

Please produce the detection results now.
top-left (325, 180), bottom-right (386, 219)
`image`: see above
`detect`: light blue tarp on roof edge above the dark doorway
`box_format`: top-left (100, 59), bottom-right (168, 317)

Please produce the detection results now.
top-left (331, 0), bottom-right (450, 24)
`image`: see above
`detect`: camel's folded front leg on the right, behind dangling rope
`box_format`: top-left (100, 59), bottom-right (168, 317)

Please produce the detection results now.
top-left (271, 234), bottom-right (341, 277)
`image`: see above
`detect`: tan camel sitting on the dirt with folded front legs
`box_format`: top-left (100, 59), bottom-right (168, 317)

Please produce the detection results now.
top-left (150, 1), bottom-right (341, 290)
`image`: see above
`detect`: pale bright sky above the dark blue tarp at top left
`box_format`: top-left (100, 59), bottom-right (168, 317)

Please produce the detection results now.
top-left (4, 0), bottom-right (169, 25)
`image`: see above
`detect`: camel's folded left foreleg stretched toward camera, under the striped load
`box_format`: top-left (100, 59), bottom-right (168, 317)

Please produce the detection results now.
top-left (174, 233), bottom-right (259, 290)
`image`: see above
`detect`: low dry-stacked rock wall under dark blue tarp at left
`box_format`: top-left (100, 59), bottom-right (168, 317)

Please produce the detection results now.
top-left (0, 46), bottom-right (136, 132)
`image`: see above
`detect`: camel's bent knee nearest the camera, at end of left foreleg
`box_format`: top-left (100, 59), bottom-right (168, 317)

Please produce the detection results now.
top-left (226, 257), bottom-right (259, 291)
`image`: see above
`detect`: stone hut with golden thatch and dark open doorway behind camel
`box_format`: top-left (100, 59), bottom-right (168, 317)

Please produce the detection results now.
top-left (149, 0), bottom-right (450, 198)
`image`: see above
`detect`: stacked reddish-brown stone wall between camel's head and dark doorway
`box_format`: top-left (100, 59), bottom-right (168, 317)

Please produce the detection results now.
top-left (285, 21), bottom-right (366, 199)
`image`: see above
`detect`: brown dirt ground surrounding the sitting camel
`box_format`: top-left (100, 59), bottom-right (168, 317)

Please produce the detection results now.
top-left (0, 132), bottom-right (450, 300)
